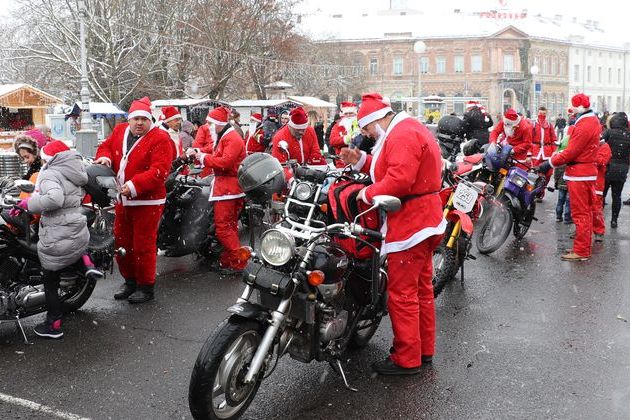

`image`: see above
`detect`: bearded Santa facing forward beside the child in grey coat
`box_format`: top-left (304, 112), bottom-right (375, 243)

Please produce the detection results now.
top-left (95, 97), bottom-right (173, 303)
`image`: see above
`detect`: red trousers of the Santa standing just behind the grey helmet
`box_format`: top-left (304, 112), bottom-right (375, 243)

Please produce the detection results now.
top-left (214, 198), bottom-right (247, 270)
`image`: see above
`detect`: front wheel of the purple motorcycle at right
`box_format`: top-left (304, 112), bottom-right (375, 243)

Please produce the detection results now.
top-left (475, 203), bottom-right (513, 255)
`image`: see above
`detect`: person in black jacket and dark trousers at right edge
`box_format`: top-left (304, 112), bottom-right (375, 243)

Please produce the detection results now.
top-left (602, 112), bottom-right (630, 228)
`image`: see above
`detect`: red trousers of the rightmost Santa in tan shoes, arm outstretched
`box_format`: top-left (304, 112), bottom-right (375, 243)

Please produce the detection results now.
top-left (567, 181), bottom-right (595, 257)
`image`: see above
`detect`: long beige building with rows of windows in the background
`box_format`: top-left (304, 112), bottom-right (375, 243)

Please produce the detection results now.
top-left (327, 26), bottom-right (569, 115)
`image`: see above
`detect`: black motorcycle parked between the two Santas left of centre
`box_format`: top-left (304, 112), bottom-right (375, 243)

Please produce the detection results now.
top-left (157, 159), bottom-right (221, 261)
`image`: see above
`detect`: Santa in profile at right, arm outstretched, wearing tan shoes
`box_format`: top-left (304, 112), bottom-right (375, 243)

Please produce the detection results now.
top-left (538, 93), bottom-right (601, 261)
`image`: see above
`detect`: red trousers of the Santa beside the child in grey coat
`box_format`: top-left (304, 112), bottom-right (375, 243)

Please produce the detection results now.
top-left (114, 203), bottom-right (164, 286)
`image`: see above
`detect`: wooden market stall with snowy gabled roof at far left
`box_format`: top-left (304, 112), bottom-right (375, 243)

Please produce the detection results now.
top-left (0, 83), bottom-right (63, 130)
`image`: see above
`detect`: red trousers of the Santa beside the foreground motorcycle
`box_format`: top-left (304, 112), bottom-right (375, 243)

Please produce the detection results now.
top-left (387, 235), bottom-right (443, 368)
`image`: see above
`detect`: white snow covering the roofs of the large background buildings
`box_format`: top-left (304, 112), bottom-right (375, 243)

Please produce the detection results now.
top-left (300, 9), bottom-right (627, 48)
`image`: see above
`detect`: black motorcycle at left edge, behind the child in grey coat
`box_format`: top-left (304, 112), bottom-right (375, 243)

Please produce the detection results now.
top-left (0, 165), bottom-right (125, 344)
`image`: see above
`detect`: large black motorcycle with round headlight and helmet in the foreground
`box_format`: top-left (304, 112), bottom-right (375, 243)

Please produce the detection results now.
top-left (188, 155), bottom-right (401, 419)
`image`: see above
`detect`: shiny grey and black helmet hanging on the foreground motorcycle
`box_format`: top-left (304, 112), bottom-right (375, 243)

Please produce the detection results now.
top-left (238, 153), bottom-right (285, 203)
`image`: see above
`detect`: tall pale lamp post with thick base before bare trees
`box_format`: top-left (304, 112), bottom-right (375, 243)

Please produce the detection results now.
top-left (75, 0), bottom-right (98, 156)
